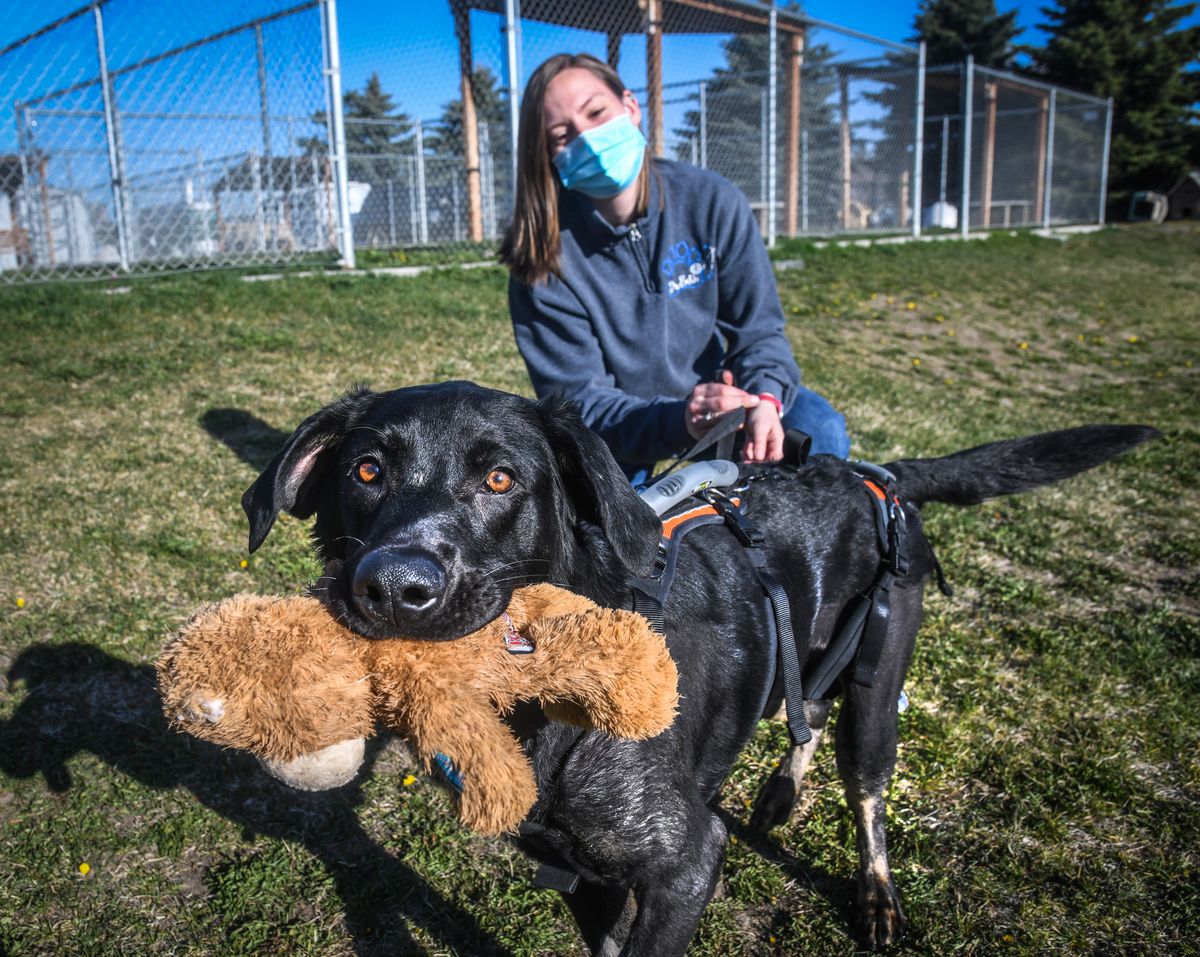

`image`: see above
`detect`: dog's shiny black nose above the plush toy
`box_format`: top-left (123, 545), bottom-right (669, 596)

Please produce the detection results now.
top-left (350, 548), bottom-right (446, 627)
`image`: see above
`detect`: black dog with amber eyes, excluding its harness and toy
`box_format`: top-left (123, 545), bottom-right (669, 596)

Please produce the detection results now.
top-left (242, 383), bottom-right (1157, 955)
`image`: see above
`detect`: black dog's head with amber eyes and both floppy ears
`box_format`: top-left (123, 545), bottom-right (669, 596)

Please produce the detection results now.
top-left (242, 383), bottom-right (660, 639)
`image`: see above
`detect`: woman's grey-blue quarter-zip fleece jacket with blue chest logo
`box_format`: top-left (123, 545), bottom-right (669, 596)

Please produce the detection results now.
top-left (509, 160), bottom-right (800, 467)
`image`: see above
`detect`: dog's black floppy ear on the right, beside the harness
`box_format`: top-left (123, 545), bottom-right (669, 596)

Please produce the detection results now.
top-left (538, 397), bottom-right (662, 574)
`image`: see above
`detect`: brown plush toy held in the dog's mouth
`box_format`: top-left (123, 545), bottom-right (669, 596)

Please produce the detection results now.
top-left (157, 584), bottom-right (678, 833)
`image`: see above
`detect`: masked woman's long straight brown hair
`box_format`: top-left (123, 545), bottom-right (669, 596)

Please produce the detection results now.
top-left (500, 53), bottom-right (650, 285)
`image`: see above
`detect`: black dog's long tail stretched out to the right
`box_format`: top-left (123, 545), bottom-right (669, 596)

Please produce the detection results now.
top-left (886, 426), bottom-right (1160, 505)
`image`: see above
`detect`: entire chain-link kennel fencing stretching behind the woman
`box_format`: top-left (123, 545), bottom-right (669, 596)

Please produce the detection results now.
top-left (0, 0), bottom-right (1111, 282)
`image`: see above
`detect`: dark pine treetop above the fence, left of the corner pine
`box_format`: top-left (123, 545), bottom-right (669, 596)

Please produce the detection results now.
top-left (912, 0), bottom-right (1021, 70)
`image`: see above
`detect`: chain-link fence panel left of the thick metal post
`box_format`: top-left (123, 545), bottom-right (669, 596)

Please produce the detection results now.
top-left (0, 0), bottom-right (350, 282)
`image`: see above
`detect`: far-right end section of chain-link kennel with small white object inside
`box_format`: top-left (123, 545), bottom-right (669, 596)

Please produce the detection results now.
top-left (922, 59), bottom-right (1112, 233)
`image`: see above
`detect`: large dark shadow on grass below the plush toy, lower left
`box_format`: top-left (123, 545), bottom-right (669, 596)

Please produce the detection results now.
top-left (0, 644), bottom-right (510, 957)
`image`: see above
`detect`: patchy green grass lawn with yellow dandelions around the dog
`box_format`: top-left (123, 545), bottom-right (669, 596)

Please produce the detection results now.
top-left (0, 227), bottom-right (1200, 957)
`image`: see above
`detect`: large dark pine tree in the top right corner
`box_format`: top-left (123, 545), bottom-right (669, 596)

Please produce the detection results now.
top-left (1031, 0), bottom-right (1200, 194)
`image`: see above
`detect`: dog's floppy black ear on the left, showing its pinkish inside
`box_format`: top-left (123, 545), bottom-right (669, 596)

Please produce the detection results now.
top-left (241, 387), bottom-right (374, 553)
